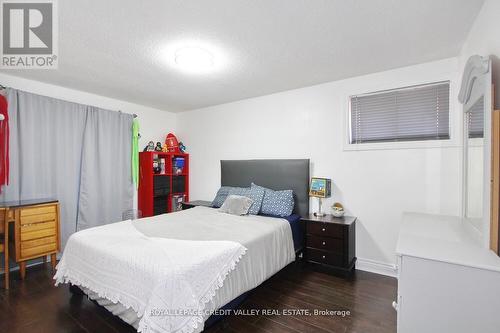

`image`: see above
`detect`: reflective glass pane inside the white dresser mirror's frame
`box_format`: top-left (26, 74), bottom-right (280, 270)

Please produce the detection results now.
top-left (464, 96), bottom-right (485, 229)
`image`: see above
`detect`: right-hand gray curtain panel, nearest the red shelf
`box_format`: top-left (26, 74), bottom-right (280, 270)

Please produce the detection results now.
top-left (77, 107), bottom-right (134, 230)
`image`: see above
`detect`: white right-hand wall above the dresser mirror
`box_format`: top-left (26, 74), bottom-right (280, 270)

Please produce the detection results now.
top-left (460, 0), bottom-right (500, 109)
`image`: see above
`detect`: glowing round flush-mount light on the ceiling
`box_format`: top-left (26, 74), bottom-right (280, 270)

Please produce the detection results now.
top-left (174, 46), bottom-right (215, 73)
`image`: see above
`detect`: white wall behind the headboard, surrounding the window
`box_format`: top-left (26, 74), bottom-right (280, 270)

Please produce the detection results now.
top-left (177, 58), bottom-right (461, 274)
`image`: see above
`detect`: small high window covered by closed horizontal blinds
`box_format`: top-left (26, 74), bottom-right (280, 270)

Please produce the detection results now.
top-left (350, 81), bottom-right (450, 144)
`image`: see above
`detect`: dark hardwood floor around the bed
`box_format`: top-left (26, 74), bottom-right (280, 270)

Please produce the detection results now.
top-left (0, 264), bottom-right (397, 333)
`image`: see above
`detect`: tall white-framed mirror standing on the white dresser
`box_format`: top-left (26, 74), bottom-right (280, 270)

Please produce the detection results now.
top-left (458, 55), bottom-right (494, 248)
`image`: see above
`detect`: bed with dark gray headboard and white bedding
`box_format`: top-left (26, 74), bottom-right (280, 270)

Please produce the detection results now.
top-left (54, 159), bottom-right (309, 333)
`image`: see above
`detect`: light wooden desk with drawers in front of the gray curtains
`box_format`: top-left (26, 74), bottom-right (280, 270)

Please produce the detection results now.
top-left (0, 199), bottom-right (60, 279)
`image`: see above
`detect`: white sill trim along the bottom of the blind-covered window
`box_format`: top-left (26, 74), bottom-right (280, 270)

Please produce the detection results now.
top-left (343, 140), bottom-right (461, 151)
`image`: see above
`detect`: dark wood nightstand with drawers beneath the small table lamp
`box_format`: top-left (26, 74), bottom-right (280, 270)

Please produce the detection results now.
top-left (302, 214), bottom-right (356, 275)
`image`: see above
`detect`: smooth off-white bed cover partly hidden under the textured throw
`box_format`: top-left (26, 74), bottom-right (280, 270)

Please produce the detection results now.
top-left (80, 207), bottom-right (294, 328)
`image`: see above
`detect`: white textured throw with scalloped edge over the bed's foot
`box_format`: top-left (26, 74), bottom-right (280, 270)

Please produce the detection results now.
top-left (54, 215), bottom-right (246, 333)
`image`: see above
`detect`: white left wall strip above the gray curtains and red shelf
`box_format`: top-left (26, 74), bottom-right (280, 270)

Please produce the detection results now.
top-left (0, 73), bottom-right (176, 207)
